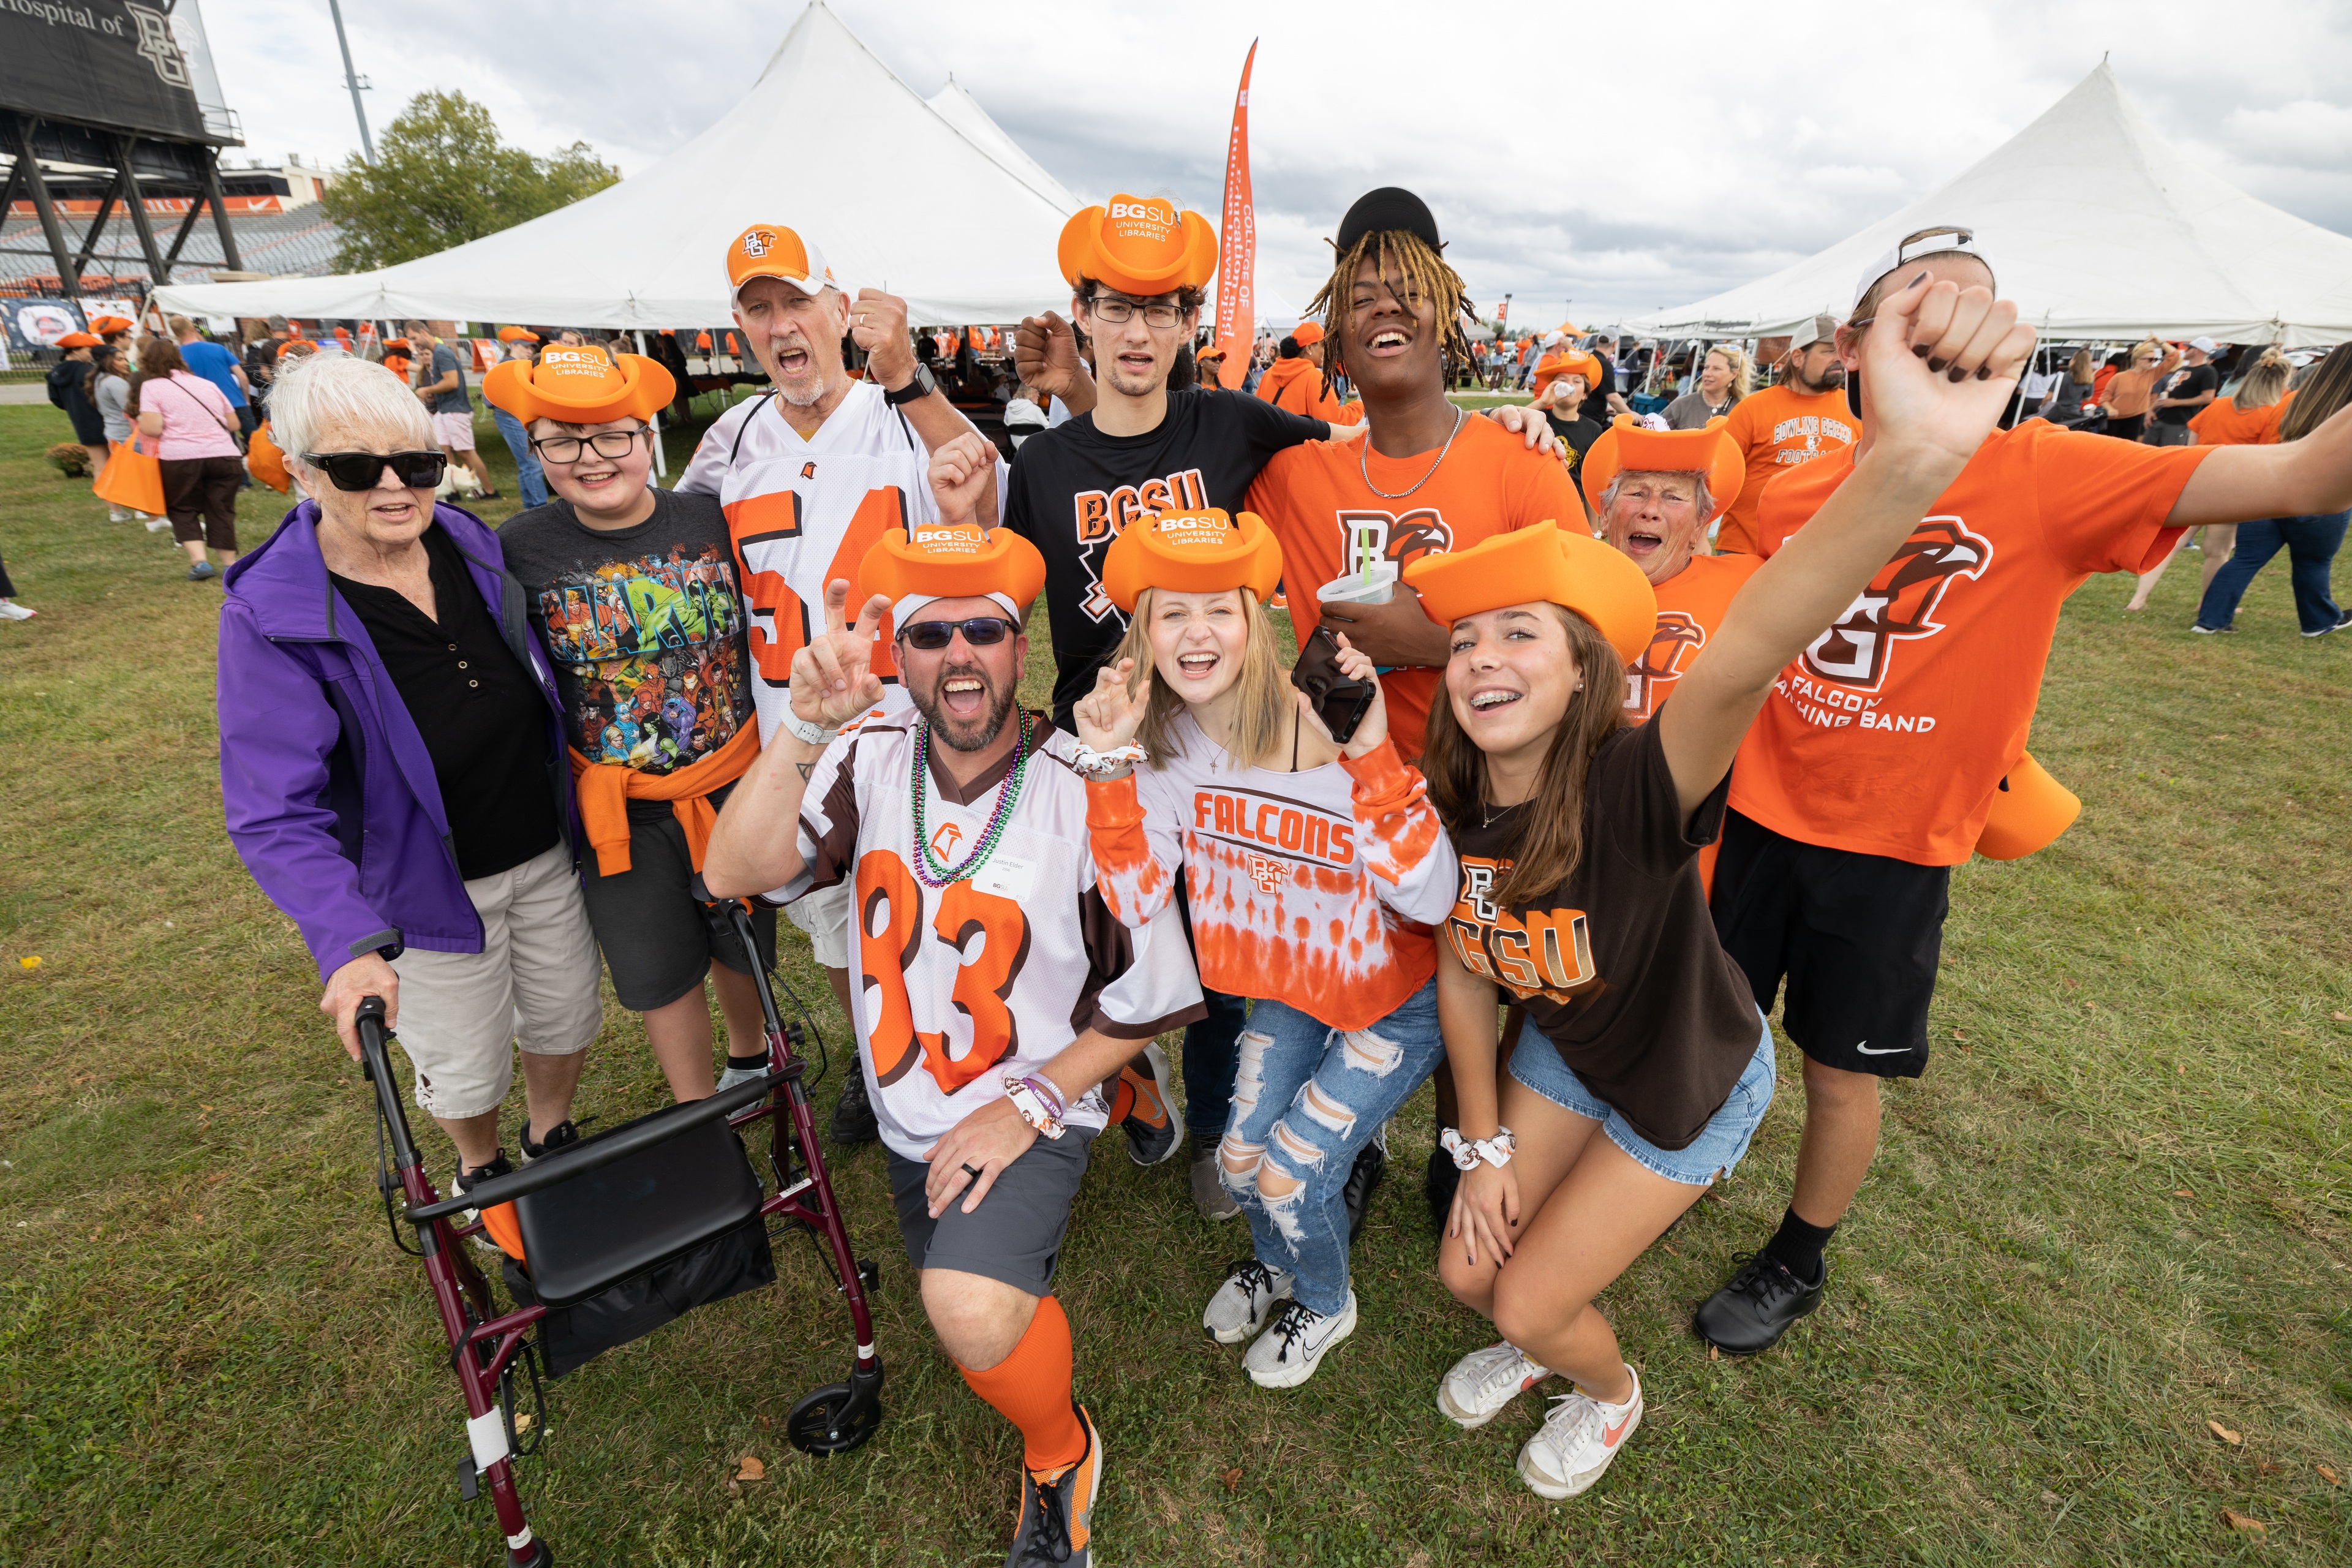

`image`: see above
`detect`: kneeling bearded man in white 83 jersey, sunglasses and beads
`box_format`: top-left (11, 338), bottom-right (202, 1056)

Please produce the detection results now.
top-left (703, 435), bottom-right (1202, 1563)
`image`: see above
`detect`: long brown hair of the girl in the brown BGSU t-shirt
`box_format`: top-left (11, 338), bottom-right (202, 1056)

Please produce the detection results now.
top-left (1420, 604), bottom-right (1625, 907)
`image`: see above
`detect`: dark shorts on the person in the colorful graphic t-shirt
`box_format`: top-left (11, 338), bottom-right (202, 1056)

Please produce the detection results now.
top-left (581, 799), bottom-right (776, 1013)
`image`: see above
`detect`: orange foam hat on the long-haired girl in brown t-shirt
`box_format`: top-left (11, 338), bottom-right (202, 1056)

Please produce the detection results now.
top-left (1404, 522), bottom-right (1658, 663)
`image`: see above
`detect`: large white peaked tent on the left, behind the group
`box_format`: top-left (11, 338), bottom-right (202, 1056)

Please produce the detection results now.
top-left (155, 0), bottom-right (1077, 326)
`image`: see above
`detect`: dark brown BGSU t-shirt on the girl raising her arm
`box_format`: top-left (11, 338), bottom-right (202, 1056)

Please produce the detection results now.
top-left (1447, 724), bottom-right (1762, 1150)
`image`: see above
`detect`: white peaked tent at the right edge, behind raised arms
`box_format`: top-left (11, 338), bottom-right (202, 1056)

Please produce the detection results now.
top-left (1630, 61), bottom-right (2352, 345)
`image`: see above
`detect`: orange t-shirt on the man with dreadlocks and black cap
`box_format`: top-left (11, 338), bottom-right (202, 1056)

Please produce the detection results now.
top-left (1246, 414), bottom-right (1585, 762)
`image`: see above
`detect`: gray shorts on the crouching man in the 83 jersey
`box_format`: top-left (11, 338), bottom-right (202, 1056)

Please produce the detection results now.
top-left (884, 1126), bottom-right (1096, 1295)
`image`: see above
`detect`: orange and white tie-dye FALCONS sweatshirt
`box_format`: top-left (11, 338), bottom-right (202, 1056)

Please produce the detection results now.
top-left (1087, 715), bottom-right (1456, 1030)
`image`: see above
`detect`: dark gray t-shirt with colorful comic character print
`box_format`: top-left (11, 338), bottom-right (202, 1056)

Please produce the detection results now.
top-left (499, 489), bottom-right (750, 785)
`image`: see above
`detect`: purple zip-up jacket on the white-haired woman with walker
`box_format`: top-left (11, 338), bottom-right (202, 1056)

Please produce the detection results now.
top-left (219, 501), bottom-right (579, 982)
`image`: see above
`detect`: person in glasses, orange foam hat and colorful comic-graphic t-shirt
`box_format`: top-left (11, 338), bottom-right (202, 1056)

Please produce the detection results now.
top-left (482, 345), bottom-right (776, 1100)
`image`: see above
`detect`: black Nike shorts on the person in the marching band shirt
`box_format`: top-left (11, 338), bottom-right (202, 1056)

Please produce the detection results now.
top-left (1710, 811), bottom-right (1952, 1079)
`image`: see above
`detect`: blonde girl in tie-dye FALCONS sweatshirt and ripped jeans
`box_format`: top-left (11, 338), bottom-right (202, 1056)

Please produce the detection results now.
top-left (1077, 508), bottom-right (1453, 1389)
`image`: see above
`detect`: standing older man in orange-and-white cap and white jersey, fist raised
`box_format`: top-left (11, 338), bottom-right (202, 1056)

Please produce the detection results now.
top-left (677, 224), bottom-right (1005, 1142)
